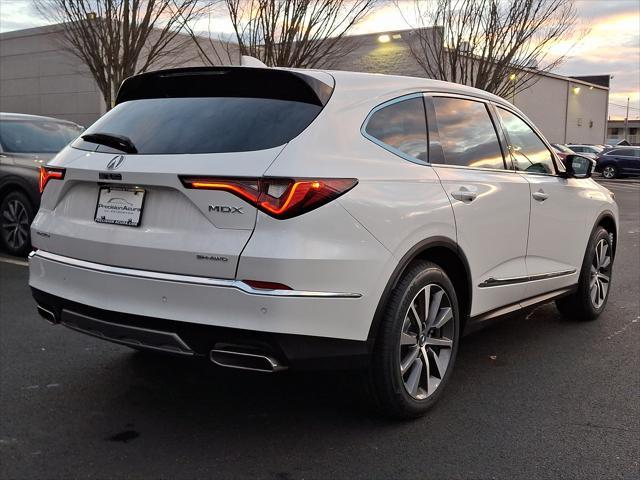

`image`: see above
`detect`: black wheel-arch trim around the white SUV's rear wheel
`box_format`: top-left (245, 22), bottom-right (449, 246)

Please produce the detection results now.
top-left (367, 237), bottom-right (473, 344)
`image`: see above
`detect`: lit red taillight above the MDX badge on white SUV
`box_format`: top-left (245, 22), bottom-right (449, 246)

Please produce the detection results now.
top-left (180, 177), bottom-right (358, 219)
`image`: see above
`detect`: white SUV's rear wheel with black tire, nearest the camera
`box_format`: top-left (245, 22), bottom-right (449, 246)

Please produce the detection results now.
top-left (370, 261), bottom-right (460, 418)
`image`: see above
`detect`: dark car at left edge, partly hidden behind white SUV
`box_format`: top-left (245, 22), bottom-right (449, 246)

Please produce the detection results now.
top-left (0, 113), bottom-right (82, 255)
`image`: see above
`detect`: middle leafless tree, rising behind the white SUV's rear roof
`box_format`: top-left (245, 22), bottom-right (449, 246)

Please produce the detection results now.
top-left (193, 0), bottom-right (378, 68)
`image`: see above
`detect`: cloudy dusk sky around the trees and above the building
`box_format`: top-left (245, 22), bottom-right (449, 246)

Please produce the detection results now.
top-left (0, 0), bottom-right (640, 118)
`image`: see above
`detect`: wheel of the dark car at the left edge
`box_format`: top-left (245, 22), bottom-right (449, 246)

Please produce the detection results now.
top-left (0, 191), bottom-right (35, 257)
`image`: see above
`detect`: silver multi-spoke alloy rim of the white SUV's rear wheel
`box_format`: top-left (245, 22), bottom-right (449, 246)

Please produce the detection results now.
top-left (400, 284), bottom-right (455, 400)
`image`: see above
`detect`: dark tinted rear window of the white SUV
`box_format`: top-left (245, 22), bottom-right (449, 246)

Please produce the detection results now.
top-left (73, 97), bottom-right (322, 154)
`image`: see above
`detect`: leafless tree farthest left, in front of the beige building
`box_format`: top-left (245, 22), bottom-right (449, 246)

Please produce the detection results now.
top-left (34, 0), bottom-right (202, 109)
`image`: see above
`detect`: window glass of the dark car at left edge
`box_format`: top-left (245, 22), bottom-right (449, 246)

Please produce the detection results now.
top-left (0, 120), bottom-right (82, 153)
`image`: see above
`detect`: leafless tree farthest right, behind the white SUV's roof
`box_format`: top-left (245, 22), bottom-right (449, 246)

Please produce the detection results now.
top-left (395, 0), bottom-right (586, 97)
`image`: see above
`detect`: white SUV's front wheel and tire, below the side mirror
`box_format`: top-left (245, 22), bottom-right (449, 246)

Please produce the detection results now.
top-left (556, 227), bottom-right (614, 321)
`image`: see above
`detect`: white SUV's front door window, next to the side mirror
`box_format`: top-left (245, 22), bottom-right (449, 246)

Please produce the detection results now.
top-left (497, 107), bottom-right (555, 175)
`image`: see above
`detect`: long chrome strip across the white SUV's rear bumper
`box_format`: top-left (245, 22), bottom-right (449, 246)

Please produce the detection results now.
top-left (30, 250), bottom-right (362, 298)
